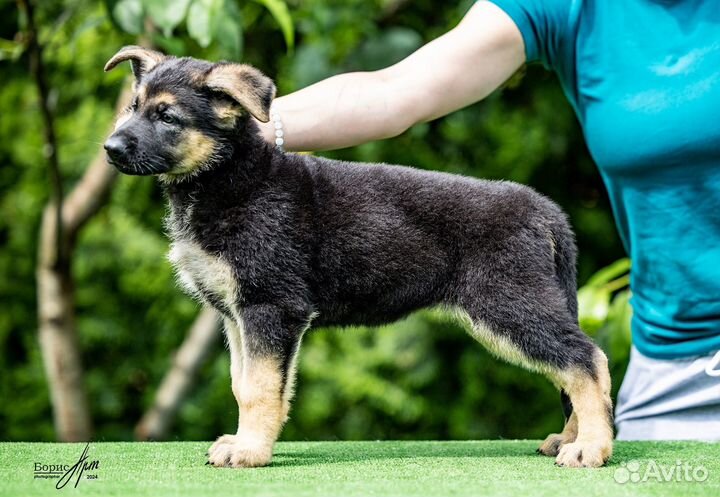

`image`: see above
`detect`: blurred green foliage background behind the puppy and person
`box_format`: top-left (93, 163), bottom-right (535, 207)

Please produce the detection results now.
top-left (0, 0), bottom-right (630, 440)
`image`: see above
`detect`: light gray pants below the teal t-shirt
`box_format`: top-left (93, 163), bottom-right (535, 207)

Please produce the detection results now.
top-left (615, 347), bottom-right (720, 441)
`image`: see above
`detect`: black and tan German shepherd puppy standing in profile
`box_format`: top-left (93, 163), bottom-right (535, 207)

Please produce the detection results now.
top-left (105, 46), bottom-right (613, 467)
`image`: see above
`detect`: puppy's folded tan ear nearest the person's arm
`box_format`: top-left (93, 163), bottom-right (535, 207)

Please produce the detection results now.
top-left (205, 63), bottom-right (275, 123)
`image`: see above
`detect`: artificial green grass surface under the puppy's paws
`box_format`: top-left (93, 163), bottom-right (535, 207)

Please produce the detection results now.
top-left (0, 440), bottom-right (720, 497)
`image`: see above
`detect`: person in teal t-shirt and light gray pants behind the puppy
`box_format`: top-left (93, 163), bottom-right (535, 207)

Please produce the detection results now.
top-left (261, 0), bottom-right (720, 440)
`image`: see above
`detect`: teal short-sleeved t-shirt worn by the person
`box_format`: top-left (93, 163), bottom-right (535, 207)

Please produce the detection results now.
top-left (491, 0), bottom-right (720, 359)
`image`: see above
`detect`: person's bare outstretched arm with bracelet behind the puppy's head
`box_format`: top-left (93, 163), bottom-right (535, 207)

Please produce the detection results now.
top-left (260, 1), bottom-right (525, 150)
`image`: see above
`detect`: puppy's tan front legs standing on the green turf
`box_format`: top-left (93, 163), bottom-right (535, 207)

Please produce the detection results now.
top-left (208, 306), bottom-right (302, 467)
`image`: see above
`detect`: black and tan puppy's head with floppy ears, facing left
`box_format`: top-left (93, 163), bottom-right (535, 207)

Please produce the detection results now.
top-left (105, 46), bottom-right (275, 180)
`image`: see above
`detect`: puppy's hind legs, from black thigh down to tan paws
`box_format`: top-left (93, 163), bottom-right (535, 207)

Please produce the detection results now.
top-left (464, 286), bottom-right (613, 467)
